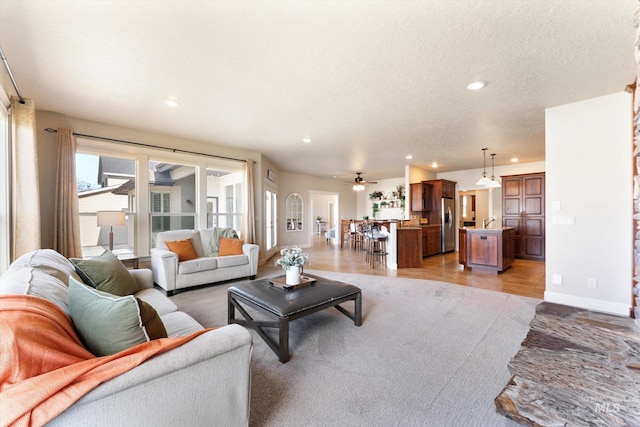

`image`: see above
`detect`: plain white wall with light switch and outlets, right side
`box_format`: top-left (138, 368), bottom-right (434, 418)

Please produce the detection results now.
top-left (545, 92), bottom-right (633, 316)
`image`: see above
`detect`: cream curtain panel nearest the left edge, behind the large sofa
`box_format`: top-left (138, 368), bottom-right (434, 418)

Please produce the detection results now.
top-left (11, 96), bottom-right (40, 261)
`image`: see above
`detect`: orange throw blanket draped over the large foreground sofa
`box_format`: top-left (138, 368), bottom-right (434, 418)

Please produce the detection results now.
top-left (0, 295), bottom-right (207, 426)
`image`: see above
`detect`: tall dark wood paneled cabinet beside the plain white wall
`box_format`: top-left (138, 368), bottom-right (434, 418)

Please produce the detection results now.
top-left (501, 172), bottom-right (545, 261)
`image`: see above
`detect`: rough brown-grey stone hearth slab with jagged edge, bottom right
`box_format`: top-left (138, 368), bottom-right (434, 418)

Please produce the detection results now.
top-left (496, 302), bottom-right (640, 426)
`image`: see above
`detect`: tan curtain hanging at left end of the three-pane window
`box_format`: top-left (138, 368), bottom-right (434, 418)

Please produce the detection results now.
top-left (53, 128), bottom-right (82, 258)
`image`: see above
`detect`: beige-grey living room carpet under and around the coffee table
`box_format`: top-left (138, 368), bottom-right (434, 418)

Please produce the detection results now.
top-left (172, 271), bottom-right (540, 426)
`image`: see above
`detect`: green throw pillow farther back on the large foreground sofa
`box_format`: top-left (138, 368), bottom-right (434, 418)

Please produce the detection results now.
top-left (71, 251), bottom-right (140, 296)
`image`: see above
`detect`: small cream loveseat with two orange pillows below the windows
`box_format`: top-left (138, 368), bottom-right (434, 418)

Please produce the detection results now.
top-left (151, 228), bottom-right (259, 295)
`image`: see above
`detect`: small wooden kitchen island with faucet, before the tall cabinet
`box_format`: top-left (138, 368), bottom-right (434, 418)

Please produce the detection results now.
top-left (458, 227), bottom-right (515, 274)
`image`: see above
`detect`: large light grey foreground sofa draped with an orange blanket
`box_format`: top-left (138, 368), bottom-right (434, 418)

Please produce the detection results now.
top-left (0, 249), bottom-right (252, 426)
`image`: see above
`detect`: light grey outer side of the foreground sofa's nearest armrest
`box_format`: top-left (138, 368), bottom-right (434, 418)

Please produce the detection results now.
top-left (48, 325), bottom-right (252, 427)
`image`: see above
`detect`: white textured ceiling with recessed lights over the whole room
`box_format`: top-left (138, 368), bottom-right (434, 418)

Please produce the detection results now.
top-left (0, 0), bottom-right (638, 180)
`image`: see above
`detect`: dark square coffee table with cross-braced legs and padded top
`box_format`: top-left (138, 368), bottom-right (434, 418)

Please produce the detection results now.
top-left (227, 274), bottom-right (362, 363)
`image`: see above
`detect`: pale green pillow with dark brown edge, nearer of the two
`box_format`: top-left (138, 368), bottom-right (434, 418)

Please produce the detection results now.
top-left (69, 277), bottom-right (167, 356)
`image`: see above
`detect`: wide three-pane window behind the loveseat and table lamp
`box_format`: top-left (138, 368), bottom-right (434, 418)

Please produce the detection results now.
top-left (76, 138), bottom-right (244, 257)
